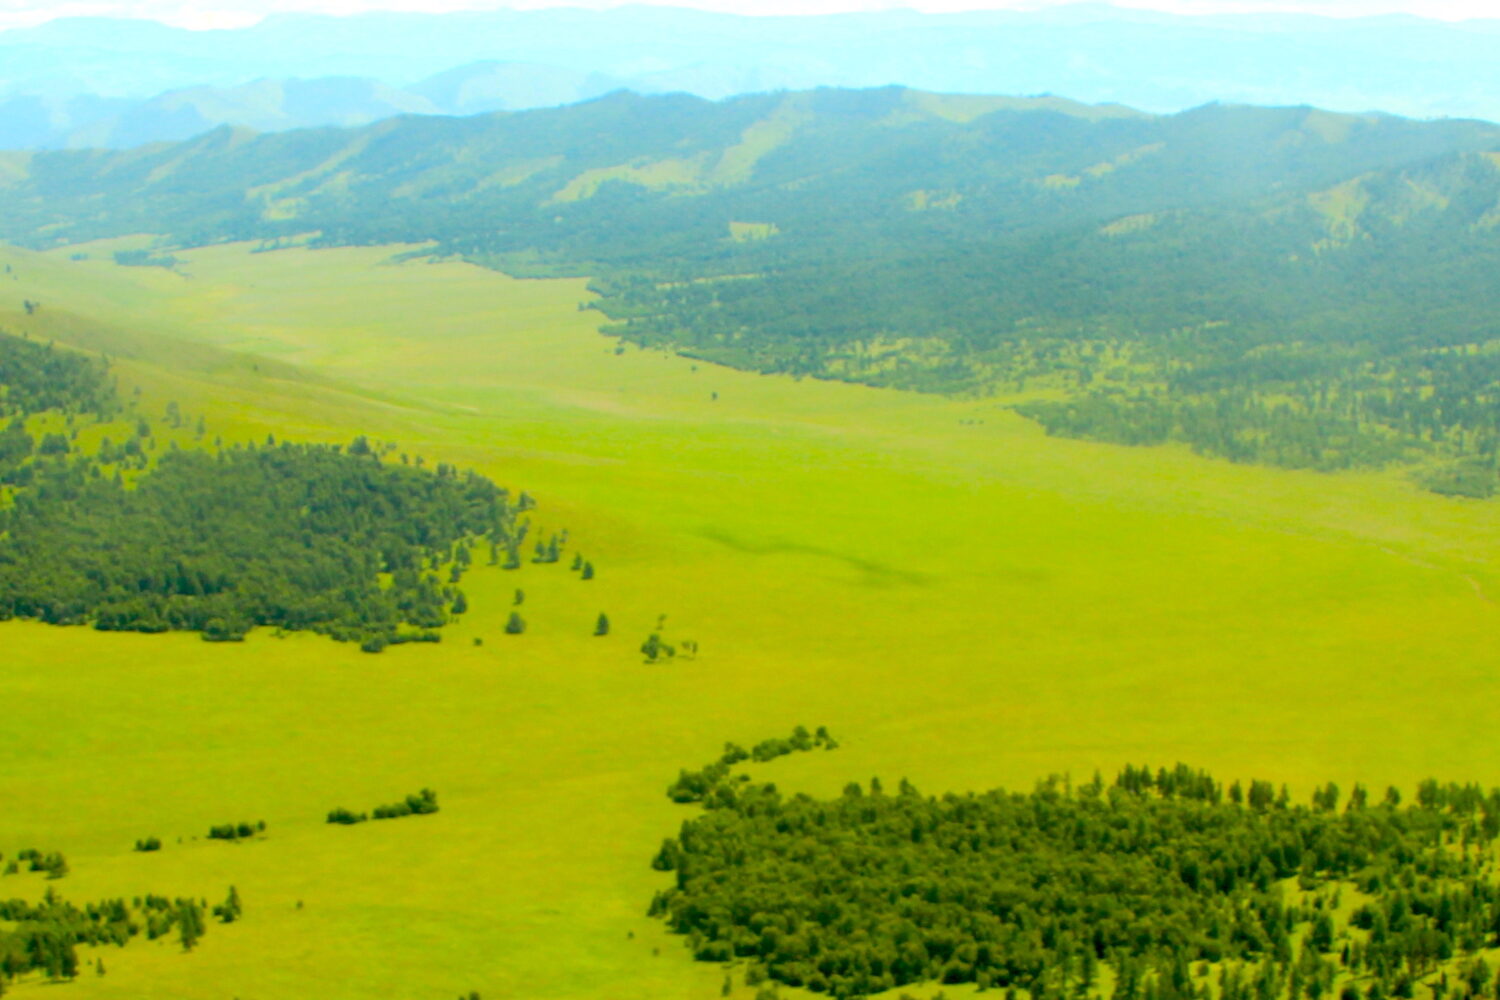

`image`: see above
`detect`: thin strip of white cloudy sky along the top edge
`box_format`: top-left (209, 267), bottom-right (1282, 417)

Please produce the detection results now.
top-left (0, 0), bottom-right (1500, 28)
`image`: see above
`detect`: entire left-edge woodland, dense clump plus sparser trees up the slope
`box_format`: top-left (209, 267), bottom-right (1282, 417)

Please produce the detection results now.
top-left (0, 333), bottom-right (531, 641)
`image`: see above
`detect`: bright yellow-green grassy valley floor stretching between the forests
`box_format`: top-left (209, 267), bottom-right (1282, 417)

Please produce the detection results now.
top-left (0, 244), bottom-right (1500, 1000)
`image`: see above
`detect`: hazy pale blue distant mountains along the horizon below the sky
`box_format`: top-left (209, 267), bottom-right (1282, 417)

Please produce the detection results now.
top-left (0, 4), bottom-right (1500, 148)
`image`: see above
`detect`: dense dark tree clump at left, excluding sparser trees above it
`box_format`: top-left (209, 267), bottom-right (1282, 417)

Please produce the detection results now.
top-left (0, 444), bottom-right (516, 645)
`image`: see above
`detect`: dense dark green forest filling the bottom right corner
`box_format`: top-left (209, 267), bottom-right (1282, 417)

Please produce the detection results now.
top-left (651, 765), bottom-right (1500, 1000)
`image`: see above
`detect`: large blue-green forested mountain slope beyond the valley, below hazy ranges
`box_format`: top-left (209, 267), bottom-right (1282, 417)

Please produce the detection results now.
top-left (0, 88), bottom-right (1500, 496)
